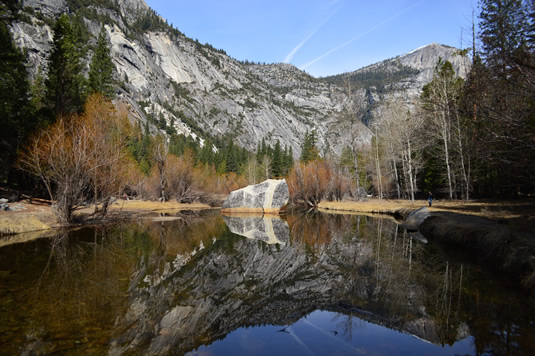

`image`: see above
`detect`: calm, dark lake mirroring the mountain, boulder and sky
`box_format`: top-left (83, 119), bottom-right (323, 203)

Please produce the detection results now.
top-left (0, 211), bottom-right (535, 355)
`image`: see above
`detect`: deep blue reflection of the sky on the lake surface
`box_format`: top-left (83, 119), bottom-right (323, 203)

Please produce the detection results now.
top-left (191, 310), bottom-right (473, 356)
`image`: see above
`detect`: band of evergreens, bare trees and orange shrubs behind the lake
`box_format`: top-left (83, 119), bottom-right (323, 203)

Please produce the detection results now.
top-left (0, 0), bottom-right (535, 222)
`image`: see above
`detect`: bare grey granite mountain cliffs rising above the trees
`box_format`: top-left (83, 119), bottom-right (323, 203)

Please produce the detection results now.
top-left (12, 0), bottom-right (472, 154)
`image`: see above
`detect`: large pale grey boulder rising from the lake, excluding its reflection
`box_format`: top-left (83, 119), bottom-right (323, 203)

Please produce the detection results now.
top-left (222, 179), bottom-right (290, 214)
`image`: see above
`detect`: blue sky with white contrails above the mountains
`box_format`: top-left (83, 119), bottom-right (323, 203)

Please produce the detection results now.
top-left (145, 0), bottom-right (478, 77)
